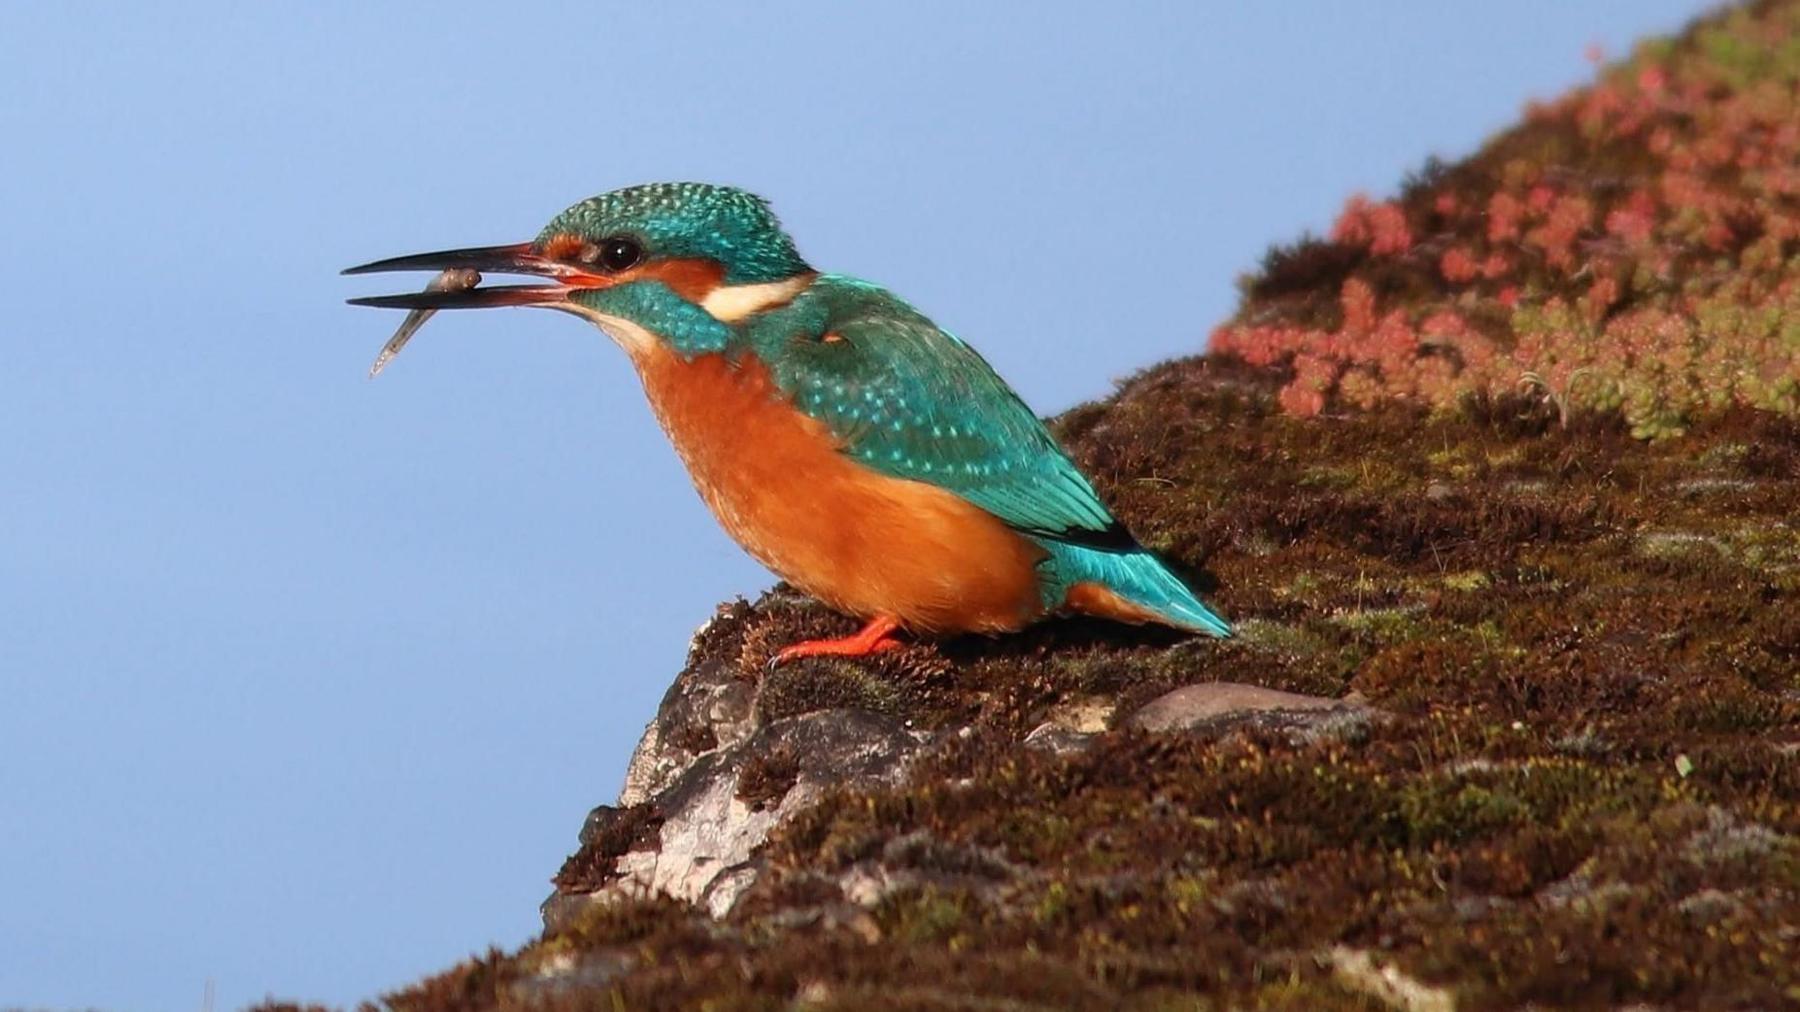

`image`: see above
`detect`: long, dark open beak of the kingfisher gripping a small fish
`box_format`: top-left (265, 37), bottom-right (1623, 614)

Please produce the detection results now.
top-left (344, 243), bottom-right (612, 310)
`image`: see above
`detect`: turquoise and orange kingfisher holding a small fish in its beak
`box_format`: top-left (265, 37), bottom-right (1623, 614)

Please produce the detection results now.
top-left (344, 182), bottom-right (1231, 664)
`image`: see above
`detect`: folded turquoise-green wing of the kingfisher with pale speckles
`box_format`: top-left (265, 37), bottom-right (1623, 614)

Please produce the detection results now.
top-left (756, 279), bottom-right (1136, 551)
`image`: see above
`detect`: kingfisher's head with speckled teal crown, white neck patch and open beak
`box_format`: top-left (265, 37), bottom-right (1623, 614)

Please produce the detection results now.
top-left (344, 182), bottom-right (814, 353)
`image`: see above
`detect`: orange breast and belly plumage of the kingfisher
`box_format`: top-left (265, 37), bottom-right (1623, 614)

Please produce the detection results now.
top-left (635, 348), bottom-right (1042, 632)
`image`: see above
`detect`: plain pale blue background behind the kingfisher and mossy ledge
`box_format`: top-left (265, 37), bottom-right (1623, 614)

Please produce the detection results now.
top-left (0, 0), bottom-right (1705, 1008)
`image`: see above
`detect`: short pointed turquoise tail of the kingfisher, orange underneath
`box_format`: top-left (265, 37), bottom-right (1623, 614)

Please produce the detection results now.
top-left (1040, 542), bottom-right (1231, 637)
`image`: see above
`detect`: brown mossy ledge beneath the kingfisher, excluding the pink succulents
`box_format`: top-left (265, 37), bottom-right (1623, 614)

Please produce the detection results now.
top-left (270, 2), bottom-right (1800, 1012)
